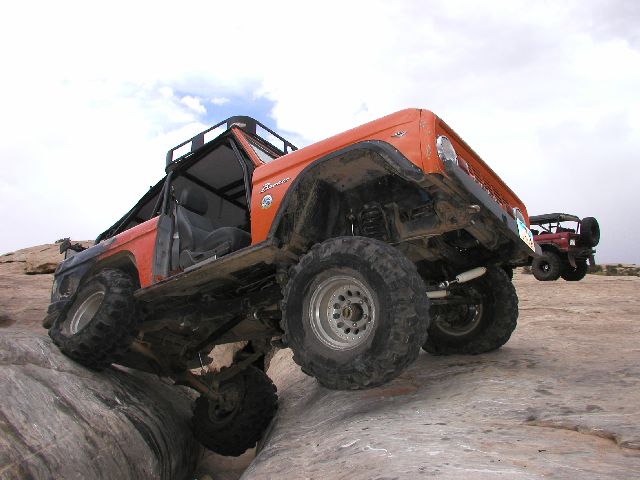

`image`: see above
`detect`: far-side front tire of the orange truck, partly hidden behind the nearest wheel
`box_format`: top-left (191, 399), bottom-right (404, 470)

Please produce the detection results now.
top-left (423, 267), bottom-right (518, 355)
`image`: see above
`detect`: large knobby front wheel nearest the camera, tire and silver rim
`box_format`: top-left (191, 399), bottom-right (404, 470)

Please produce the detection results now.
top-left (282, 237), bottom-right (429, 390)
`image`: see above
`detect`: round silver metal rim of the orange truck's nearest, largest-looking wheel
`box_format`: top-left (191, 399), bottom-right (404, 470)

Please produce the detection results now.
top-left (309, 275), bottom-right (376, 350)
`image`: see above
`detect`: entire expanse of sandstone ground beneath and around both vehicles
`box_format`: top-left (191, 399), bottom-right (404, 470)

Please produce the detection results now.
top-left (0, 244), bottom-right (640, 480)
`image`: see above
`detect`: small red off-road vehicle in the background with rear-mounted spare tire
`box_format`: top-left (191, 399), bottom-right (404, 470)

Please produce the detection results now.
top-left (530, 213), bottom-right (600, 282)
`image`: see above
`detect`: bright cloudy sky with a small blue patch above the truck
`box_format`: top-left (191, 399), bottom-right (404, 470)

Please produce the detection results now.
top-left (0, 0), bottom-right (640, 263)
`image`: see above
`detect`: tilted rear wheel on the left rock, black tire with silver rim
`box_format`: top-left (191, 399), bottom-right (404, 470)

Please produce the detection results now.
top-left (49, 269), bottom-right (139, 370)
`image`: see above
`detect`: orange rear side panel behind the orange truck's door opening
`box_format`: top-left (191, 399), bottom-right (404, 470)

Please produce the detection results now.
top-left (98, 217), bottom-right (159, 288)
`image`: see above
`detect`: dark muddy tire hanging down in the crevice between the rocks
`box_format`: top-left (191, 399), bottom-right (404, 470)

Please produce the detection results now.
top-left (192, 366), bottom-right (278, 457)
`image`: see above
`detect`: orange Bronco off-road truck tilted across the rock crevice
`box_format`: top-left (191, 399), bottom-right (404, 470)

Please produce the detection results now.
top-left (44, 109), bottom-right (539, 455)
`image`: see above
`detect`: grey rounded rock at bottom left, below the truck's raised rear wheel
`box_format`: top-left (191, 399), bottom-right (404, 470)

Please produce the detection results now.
top-left (0, 330), bottom-right (201, 479)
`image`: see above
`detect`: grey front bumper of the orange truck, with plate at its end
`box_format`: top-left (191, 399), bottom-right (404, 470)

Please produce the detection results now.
top-left (443, 162), bottom-right (542, 258)
